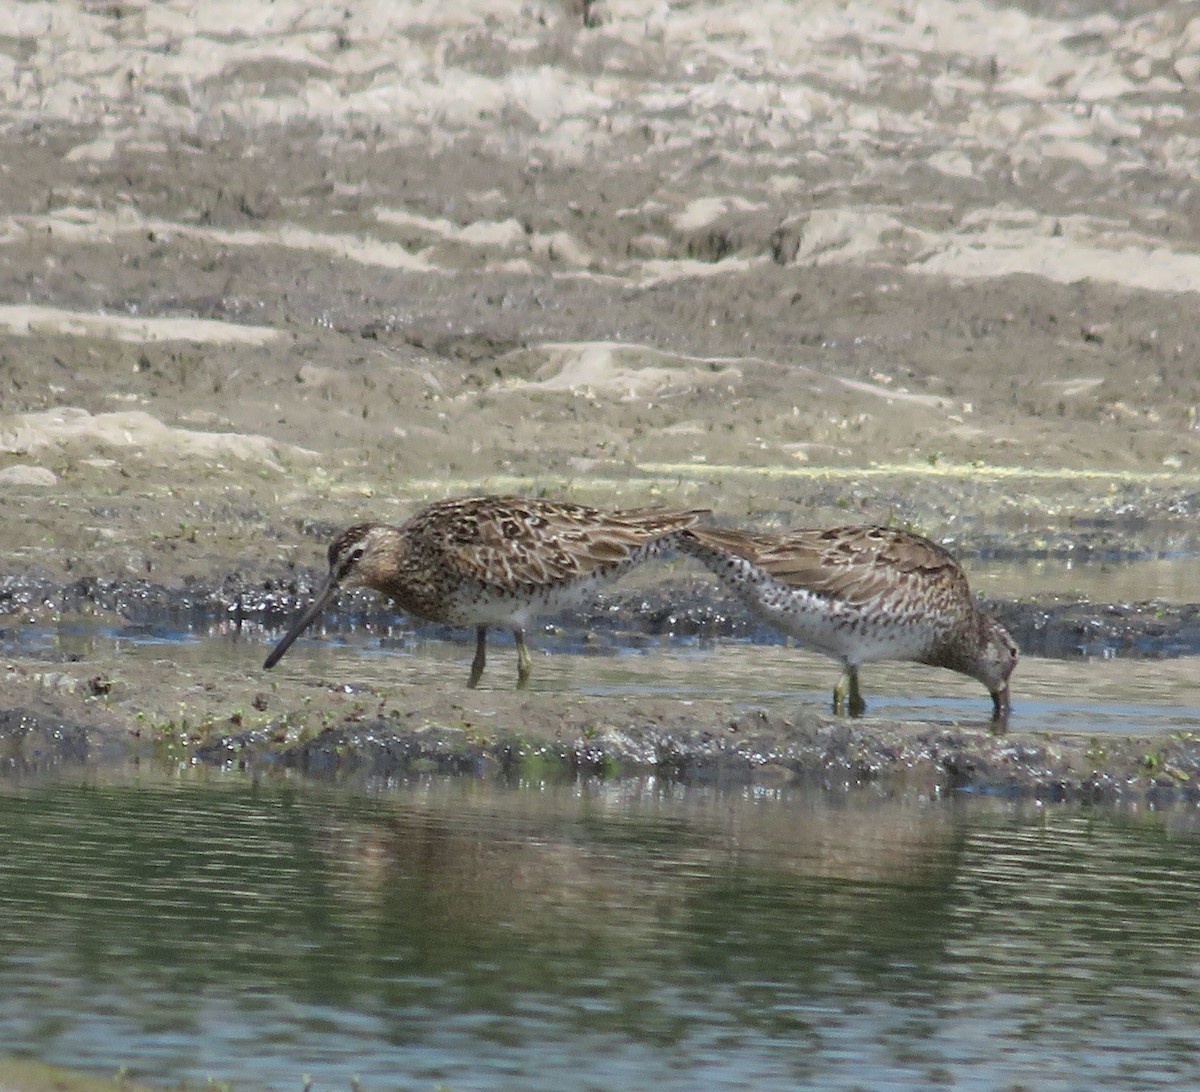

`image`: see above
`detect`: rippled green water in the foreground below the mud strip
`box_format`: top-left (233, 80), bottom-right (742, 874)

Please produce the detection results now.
top-left (0, 776), bottom-right (1200, 1090)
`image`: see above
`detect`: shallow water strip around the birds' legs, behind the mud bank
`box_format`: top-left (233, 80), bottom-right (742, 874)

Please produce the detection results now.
top-left (14, 602), bottom-right (1200, 734)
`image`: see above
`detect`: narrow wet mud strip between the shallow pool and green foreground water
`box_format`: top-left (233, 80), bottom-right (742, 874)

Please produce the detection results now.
top-left (7, 678), bottom-right (1200, 809)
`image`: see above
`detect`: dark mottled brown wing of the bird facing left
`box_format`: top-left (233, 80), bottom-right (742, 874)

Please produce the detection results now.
top-left (427, 497), bottom-right (702, 587)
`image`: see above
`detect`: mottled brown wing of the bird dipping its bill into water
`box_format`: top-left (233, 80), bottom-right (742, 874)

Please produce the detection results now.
top-left (691, 527), bottom-right (967, 604)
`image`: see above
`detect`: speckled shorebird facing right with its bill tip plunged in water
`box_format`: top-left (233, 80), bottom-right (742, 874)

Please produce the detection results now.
top-left (676, 527), bottom-right (1018, 721)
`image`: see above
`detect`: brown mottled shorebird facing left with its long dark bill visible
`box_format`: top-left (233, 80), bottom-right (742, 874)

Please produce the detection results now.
top-left (263, 496), bottom-right (708, 689)
